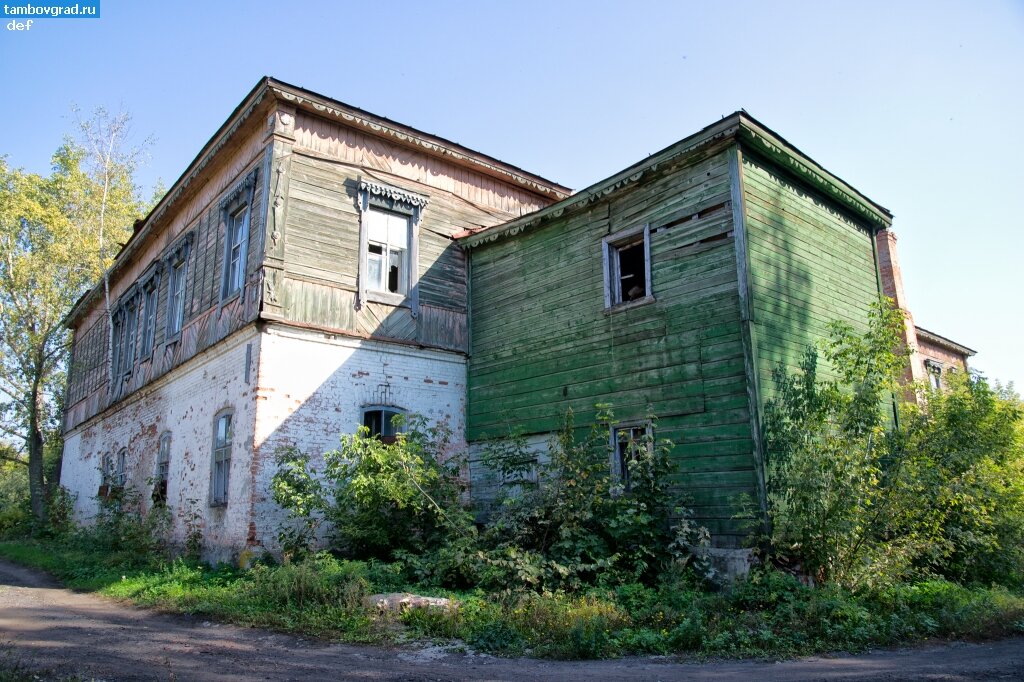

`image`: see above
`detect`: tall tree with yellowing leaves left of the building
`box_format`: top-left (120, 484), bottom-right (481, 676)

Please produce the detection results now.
top-left (0, 111), bottom-right (143, 522)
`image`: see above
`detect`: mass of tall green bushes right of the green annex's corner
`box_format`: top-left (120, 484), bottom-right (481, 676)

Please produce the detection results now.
top-left (766, 301), bottom-right (1024, 589)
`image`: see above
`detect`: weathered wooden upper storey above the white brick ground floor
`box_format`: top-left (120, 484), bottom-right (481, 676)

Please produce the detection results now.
top-left (65, 79), bottom-right (568, 429)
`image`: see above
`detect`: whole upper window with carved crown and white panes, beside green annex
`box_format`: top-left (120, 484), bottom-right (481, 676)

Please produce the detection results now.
top-left (356, 180), bottom-right (427, 317)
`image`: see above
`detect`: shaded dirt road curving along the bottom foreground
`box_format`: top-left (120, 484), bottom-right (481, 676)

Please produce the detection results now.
top-left (0, 561), bottom-right (1024, 682)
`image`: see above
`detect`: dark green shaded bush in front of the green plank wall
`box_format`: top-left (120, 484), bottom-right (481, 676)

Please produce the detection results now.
top-left (481, 406), bottom-right (709, 590)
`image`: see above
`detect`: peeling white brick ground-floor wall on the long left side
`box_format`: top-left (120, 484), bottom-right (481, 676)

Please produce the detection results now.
top-left (60, 326), bottom-right (260, 559)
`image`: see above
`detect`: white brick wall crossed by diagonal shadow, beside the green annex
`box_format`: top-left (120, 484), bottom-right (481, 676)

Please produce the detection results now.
top-left (253, 325), bottom-right (466, 549)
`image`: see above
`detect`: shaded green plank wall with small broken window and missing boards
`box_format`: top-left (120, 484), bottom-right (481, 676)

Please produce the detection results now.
top-left (467, 146), bottom-right (757, 546)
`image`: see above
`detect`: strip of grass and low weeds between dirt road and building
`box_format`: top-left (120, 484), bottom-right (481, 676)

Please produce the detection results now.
top-left (0, 541), bottom-right (1024, 658)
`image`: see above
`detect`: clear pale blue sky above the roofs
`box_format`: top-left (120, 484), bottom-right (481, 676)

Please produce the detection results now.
top-left (0, 0), bottom-right (1024, 389)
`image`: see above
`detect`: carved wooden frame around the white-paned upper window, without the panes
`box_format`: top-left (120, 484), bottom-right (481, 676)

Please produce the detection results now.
top-left (355, 179), bottom-right (428, 317)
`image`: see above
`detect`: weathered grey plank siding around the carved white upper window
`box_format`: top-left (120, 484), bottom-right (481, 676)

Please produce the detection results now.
top-left (279, 150), bottom-right (516, 352)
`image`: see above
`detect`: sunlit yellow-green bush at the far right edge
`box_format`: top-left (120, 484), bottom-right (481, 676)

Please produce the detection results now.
top-left (895, 373), bottom-right (1024, 587)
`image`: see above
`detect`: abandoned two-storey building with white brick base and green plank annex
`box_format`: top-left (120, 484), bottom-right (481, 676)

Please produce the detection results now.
top-left (61, 78), bottom-right (962, 558)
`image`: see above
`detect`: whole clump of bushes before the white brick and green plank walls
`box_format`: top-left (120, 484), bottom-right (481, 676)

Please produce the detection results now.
top-left (272, 406), bottom-right (709, 591)
